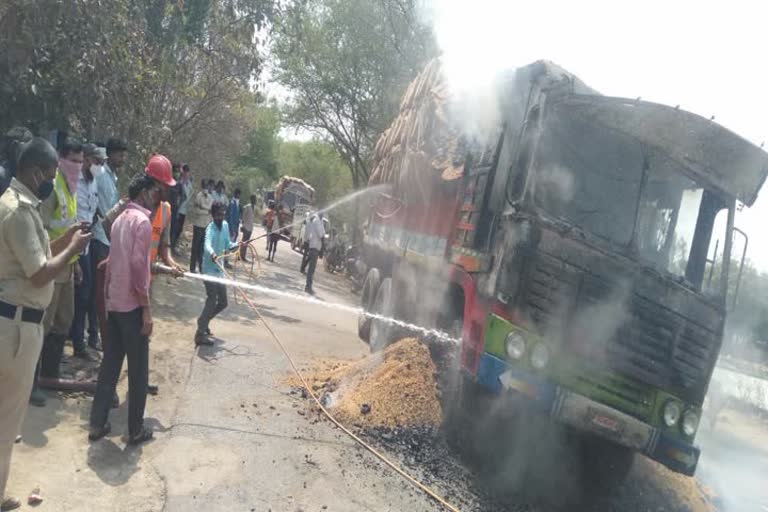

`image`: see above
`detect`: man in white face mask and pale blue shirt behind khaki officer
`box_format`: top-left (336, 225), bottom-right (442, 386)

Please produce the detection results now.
top-left (69, 144), bottom-right (107, 361)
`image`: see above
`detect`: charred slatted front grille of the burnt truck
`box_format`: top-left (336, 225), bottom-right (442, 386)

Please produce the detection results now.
top-left (523, 253), bottom-right (718, 402)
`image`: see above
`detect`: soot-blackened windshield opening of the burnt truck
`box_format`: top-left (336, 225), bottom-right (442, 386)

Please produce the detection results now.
top-left (524, 105), bottom-right (733, 296)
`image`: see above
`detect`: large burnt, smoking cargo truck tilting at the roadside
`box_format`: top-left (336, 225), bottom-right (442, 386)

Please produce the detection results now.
top-left (358, 61), bottom-right (768, 476)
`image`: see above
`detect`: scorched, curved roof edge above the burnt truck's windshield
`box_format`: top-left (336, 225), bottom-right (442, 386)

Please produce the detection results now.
top-left (508, 61), bottom-right (768, 206)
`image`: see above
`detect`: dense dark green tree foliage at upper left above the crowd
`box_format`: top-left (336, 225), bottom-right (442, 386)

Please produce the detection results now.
top-left (0, 0), bottom-right (273, 182)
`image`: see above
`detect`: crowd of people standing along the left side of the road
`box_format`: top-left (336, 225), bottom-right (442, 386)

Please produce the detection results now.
top-left (0, 128), bottom-right (256, 512)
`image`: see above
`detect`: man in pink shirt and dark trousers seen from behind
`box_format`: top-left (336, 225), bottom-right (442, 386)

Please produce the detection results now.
top-left (88, 175), bottom-right (162, 444)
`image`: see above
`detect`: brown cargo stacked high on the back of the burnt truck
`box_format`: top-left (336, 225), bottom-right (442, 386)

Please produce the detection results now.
top-left (369, 59), bottom-right (465, 200)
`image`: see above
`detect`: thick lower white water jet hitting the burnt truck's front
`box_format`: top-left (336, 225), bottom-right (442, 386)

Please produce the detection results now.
top-left (158, 265), bottom-right (460, 345)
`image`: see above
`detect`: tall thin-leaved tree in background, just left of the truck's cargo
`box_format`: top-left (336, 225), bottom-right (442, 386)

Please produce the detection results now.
top-left (271, 0), bottom-right (436, 188)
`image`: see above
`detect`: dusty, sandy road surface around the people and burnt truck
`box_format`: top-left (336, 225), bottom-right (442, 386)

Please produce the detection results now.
top-left (9, 229), bottom-right (768, 512)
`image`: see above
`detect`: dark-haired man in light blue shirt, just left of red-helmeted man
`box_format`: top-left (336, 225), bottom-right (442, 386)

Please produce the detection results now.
top-left (88, 137), bottom-right (128, 348)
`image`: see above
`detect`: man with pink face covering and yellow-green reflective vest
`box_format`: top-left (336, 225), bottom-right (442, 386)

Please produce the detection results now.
top-left (40, 138), bottom-right (84, 386)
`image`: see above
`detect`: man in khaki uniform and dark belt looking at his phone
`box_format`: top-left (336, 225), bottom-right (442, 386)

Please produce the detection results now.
top-left (0, 138), bottom-right (91, 512)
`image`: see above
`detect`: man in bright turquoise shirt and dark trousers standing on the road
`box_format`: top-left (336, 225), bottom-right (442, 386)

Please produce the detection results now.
top-left (195, 202), bottom-right (238, 345)
